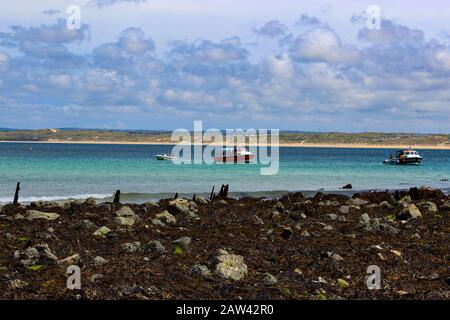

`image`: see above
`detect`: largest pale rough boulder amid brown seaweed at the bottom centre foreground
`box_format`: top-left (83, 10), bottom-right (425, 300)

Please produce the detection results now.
top-left (216, 249), bottom-right (248, 281)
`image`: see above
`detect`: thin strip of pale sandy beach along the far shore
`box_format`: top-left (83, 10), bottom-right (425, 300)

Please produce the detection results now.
top-left (0, 140), bottom-right (450, 150)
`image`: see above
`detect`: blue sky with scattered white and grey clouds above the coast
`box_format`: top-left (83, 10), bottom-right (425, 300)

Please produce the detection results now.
top-left (0, 0), bottom-right (450, 133)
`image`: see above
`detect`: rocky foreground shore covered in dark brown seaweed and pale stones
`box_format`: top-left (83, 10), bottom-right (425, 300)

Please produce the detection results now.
top-left (0, 188), bottom-right (450, 299)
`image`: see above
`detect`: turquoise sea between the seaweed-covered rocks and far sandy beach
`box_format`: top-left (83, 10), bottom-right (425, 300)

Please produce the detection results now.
top-left (0, 143), bottom-right (450, 202)
